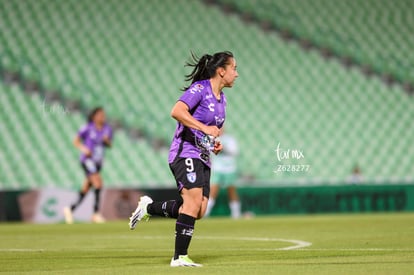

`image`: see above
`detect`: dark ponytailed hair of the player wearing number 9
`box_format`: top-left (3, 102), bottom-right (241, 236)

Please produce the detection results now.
top-left (183, 51), bottom-right (233, 91)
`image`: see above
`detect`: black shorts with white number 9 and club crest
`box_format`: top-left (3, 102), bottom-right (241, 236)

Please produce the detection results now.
top-left (170, 158), bottom-right (210, 198)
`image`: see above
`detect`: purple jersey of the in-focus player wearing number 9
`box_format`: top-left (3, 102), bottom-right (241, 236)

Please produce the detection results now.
top-left (168, 79), bottom-right (226, 166)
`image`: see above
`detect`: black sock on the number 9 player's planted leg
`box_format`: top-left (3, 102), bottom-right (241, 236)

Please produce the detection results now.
top-left (174, 214), bottom-right (195, 260)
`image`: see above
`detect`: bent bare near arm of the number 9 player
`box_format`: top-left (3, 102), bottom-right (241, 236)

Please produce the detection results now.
top-left (171, 100), bottom-right (220, 137)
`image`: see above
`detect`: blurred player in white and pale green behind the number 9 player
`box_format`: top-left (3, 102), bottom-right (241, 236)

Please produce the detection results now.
top-left (205, 127), bottom-right (241, 219)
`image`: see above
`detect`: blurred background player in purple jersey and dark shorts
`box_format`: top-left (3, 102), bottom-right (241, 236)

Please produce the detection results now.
top-left (63, 107), bottom-right (112, 224)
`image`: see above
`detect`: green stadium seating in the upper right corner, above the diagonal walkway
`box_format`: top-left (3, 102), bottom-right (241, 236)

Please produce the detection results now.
top-left (218, 0), bottom-right (414, 83)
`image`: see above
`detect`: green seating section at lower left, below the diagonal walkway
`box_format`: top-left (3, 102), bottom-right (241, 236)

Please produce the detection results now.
top-left (0, 82), bottom-right (174, 189)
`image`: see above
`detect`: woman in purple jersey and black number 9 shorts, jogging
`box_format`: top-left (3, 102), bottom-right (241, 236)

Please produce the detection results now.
top-left (129, 52), bottom-right (238, 267)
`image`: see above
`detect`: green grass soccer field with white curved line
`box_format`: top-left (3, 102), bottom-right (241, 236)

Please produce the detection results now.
top-left (0, 213), bottom-right (414, 274)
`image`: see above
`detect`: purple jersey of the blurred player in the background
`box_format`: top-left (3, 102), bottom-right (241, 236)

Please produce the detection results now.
top-left (78, 122), bottom-right (112, 163)
